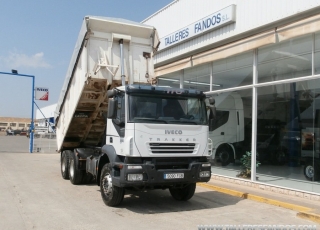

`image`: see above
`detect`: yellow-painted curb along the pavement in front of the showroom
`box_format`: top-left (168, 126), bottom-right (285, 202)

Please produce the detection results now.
top-left (198, 183), bottom-right (320, 223)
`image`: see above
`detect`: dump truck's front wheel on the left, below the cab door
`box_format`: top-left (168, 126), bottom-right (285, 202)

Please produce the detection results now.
top-left (100, 163), bottom-right (124, 207)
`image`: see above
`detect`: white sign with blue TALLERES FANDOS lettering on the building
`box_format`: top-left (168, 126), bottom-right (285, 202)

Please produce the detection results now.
top-left (159, 5), bottom-right (236, 49)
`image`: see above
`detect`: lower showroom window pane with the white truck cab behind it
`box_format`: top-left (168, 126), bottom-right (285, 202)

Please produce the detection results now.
top-left (209, 89), bottom-right (252, 177)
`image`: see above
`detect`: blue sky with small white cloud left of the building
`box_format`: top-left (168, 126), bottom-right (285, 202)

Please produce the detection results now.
top-left (0, 0), bottom-right (172, 118)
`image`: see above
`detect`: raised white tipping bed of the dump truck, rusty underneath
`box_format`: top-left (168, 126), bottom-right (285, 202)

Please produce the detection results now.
top-left (55, 16), bottom-right (158, 152)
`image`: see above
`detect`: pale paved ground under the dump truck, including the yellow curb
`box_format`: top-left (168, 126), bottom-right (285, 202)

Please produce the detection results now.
top-left (0, 136), bottom-right (320, 229)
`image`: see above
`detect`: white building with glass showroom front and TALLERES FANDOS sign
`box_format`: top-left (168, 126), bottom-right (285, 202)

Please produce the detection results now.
top-left (143, 0), bottom-right (320, 195)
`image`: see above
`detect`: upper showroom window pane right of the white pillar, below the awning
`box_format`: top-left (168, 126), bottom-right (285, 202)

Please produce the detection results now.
top-left (258, 35), bottom-right (312, 83)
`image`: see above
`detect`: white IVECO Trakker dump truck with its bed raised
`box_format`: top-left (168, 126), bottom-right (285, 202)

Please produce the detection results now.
top-left (55, 16), bottom-right (213, 206)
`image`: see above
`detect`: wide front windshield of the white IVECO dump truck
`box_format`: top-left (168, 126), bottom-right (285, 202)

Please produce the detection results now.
top-left (128, 95), bottom-right (207, 125)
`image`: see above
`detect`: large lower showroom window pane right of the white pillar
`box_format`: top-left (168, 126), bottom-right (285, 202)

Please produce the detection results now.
top-left (256, 79), bottom-right (320, 193)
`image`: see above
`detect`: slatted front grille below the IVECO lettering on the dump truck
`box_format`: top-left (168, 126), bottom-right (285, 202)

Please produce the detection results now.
top-left (149, 143), bottom-right (196, 154)
